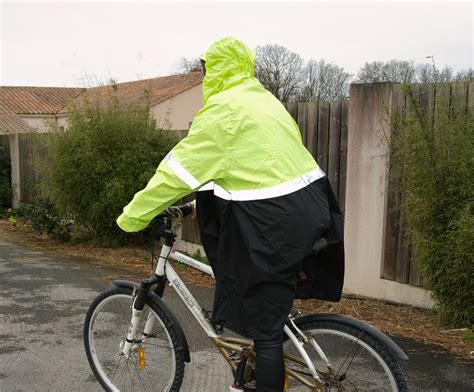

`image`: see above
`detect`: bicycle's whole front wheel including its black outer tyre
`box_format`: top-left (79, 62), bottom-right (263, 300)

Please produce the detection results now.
top-left (84, 287), bottom-right (184, 391)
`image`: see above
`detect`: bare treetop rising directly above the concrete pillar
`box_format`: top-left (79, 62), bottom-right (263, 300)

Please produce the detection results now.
top-left (356, 59), bottom-right (416, 83)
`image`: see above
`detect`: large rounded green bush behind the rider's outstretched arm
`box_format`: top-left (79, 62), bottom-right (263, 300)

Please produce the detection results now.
top-left (51, 96), bottom-right (177, 246)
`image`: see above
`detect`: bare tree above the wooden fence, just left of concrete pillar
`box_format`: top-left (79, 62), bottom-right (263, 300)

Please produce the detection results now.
top-left (300, 60), bottom-right (352, 101)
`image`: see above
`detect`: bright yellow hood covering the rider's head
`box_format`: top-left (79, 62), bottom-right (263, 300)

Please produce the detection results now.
top-left (201, 37), bottom-right (255, 105)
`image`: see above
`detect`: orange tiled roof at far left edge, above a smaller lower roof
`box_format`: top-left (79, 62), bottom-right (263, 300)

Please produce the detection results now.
top-left (0, 86), bottom-right (84, 114)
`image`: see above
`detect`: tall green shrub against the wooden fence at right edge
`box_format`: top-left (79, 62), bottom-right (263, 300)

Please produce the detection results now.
top-left (391, 87), bottom-right (474, 327)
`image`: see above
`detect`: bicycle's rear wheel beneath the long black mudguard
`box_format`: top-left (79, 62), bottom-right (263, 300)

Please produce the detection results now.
top-left (284, 315), bottom-right (408, 392)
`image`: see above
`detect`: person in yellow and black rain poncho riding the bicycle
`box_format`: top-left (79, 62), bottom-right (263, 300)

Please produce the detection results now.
top-left (117, 38), bottom-right (344, 392)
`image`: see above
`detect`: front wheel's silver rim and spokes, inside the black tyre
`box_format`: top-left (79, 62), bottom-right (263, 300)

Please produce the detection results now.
top-left (88, 294), bottom-right (176, 391)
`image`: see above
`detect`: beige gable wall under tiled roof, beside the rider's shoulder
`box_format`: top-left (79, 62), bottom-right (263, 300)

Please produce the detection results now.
top-left (151, 84), bottom-right (202, 130)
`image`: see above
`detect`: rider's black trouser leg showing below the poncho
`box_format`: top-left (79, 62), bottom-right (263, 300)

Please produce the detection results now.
top-left (254, 335), bottom-right (285, 392)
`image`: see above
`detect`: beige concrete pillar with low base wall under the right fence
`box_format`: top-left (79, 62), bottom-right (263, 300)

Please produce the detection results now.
top-left (344, 83), bottom-right (434, 308)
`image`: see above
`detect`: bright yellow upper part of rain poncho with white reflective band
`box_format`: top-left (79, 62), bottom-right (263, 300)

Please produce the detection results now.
top-left (117, 38), bottom-right (324, 232)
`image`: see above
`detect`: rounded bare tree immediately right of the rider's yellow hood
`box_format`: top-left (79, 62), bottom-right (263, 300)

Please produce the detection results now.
top-left (255, 45), bottom-right (304, 102)
